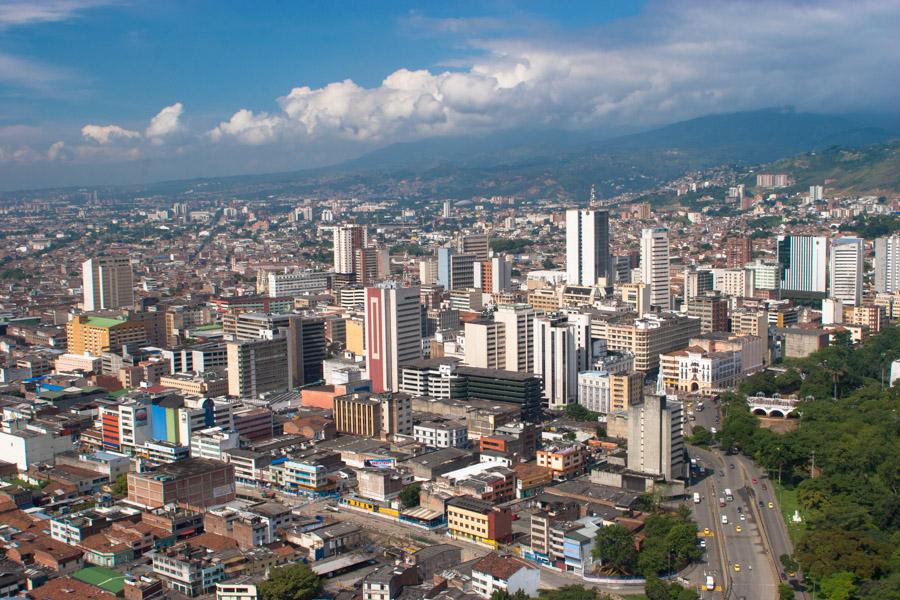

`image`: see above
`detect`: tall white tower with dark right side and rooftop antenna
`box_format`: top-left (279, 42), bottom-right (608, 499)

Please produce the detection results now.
top-left (566, 208), bottom-right (612, 287)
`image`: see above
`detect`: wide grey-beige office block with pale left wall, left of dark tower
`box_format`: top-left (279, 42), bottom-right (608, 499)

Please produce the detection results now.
top-left (226, 336), bottom-right (290, 398)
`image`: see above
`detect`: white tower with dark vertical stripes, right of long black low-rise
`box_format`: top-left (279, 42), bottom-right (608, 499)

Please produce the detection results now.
top-left (534, 316), bottom-right (590, 410)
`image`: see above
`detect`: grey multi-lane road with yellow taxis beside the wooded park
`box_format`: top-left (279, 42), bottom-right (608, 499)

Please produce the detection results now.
top-left (689, 396), bottom-right (808, 600)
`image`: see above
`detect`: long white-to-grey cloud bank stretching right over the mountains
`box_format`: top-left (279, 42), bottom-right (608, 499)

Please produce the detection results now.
top-left (210, 0), bottom-right (900, 145)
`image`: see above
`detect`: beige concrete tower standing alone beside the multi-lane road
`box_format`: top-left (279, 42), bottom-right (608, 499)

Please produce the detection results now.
top-left (628, 395), bottom-right (684, 480)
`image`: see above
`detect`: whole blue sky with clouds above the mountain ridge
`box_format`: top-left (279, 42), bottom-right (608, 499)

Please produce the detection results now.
top-left (0, 0), bottom-right (900, 190)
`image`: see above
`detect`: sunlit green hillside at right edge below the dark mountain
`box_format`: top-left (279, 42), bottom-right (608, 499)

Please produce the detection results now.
top-left (763, 140), bottom-right (900, 194)
